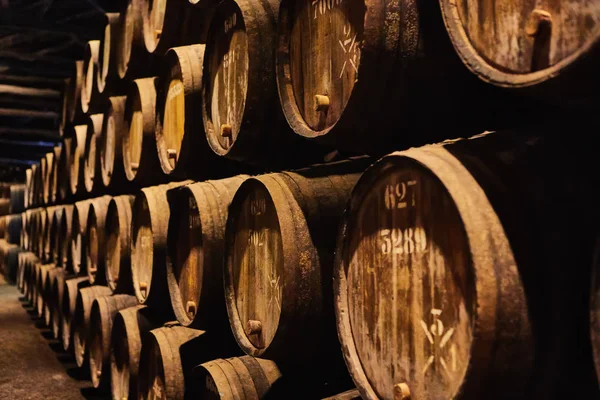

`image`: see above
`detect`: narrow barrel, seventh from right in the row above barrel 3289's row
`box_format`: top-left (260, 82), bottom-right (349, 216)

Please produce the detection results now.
top-left (83, 114), bottom-right (104, 194)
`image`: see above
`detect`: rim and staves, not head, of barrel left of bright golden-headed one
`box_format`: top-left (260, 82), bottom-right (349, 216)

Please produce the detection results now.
top-left (122, 77), bottom-right (165, 187)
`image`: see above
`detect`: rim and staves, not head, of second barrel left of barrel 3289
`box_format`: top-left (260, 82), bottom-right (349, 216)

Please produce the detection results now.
top-left (166, 175), bottom-right (249, 331)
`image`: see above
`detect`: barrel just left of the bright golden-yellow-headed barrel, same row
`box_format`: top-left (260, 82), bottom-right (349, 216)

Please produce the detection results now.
top-left (123, 77), bottom-right (164, 186)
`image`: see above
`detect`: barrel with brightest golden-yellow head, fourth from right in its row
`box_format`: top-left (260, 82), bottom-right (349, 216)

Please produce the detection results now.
top-left (156, 43), bottom-right (209, 177)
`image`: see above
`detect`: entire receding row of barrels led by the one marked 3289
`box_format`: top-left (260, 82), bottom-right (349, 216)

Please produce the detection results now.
top-left (11, 129), bottom-right (600, 399)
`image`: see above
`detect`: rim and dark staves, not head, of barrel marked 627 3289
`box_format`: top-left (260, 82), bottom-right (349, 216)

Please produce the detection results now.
top-left (334, 132), bottom-right (595, 399)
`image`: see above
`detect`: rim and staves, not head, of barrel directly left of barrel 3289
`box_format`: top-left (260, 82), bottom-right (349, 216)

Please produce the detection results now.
top-left (223, 160), bottom-right (366, 366)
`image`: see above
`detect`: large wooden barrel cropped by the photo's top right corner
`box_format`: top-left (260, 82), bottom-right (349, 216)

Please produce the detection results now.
top-left (440, 0), bottom-right (600, 97)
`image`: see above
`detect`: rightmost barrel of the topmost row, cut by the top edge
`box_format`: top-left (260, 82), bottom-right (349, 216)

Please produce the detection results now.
top-left (142, 0), bottom-right (214, 56)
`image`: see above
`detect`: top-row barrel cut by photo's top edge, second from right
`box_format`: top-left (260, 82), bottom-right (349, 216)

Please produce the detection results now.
top-left (116, 0), bottom-right (154, 80)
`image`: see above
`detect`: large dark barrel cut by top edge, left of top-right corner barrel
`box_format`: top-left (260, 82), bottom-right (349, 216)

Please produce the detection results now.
top-left (276, 0), bottom-right (489, 154)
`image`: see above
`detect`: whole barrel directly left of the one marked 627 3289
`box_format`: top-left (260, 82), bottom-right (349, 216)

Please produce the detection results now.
top-left (224, 160), bottom-right (366, 362)
